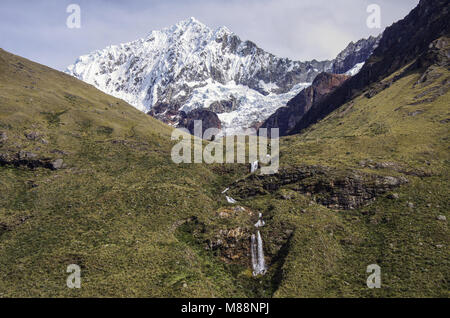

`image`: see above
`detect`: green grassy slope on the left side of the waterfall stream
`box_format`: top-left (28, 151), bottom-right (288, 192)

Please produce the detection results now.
top-left (0, 51), bottom-right (245, 297)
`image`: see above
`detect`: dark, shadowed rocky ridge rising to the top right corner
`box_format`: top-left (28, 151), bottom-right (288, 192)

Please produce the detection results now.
top-left (291, 0), bottom-right (450, 133)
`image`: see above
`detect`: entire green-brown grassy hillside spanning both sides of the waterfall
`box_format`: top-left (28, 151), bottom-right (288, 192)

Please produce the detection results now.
top-left (0, 47), bottom-right (450, 297)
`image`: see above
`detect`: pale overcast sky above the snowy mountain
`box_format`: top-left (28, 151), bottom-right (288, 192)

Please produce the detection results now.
top-left (0, 0), bottom-right (419, 70)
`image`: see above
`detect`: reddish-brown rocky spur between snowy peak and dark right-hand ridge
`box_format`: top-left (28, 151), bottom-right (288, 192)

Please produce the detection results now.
top-left (261, 73), bottom-right (350, 136)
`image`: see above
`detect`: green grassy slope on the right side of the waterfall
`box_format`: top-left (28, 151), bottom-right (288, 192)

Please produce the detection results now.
top-left (234, 62), bottom-right (450, 297)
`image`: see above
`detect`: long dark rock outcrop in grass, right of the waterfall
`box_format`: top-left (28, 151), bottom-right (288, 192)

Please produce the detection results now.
top-left (230, 166), bottom-right (408, 210)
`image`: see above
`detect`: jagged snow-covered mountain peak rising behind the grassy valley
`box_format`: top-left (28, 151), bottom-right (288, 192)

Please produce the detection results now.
top-left (67, 18), bottom-right (380, 134)
